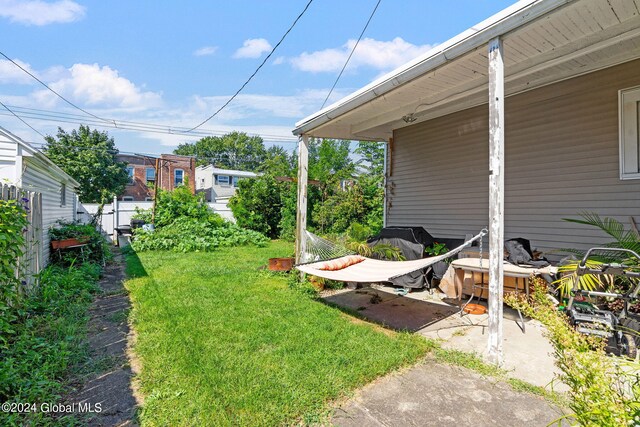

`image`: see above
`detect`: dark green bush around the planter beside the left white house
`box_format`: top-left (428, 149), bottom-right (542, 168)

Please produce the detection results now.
top-left (49, 221), bottom-right (111, 267)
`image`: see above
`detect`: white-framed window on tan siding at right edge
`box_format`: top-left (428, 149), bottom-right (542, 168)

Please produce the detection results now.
top-left (618, 87), bottom-right (640, 179)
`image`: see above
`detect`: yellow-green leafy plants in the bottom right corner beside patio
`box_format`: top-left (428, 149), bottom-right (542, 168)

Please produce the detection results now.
top-left (505, 279), bottom-right (640, 426)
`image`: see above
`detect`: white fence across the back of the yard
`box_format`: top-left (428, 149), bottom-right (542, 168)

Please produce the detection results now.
top-left (78, 199), bottom-right (235, 241)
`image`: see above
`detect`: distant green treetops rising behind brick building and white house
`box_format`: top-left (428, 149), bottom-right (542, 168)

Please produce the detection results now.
top-left (173, 132), bottom-right (267, 171)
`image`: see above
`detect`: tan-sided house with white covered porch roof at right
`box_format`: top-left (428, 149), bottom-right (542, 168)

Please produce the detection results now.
top-left (294, 0), bottom-right (640, 259)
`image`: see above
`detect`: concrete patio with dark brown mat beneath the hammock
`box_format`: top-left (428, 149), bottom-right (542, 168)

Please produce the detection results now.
top-left (324, 285), bottom-right (567, 392)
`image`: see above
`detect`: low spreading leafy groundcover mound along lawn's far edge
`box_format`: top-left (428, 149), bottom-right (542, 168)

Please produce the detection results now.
top-left (131, 217), bottom-right (269, 252)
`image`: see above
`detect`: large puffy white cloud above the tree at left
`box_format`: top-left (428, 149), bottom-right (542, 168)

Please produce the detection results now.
top-left (33, 64), bottom-right (162, 110)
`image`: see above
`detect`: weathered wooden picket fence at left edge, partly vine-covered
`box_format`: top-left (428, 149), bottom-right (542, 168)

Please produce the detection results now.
top-left (0, 184), bottom-right (45, 290)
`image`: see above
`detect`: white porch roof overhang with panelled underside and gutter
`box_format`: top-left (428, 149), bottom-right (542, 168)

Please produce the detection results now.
top-left (293, 0), bottom-right (640, 141)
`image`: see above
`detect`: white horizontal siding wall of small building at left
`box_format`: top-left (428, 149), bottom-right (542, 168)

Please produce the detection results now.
top-left (22, 157), bottom-right (76, 265)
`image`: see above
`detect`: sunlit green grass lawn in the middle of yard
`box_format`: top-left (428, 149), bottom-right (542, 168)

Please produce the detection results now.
top-left (127, 242), bottom-right (429, 426)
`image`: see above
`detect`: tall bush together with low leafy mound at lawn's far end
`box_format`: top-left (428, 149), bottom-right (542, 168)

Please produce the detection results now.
top-left (131, 186), bottom-right (268, 252)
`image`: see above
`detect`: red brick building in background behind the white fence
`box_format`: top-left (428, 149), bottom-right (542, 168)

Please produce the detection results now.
top-left (118, 154), bottom-right (196, 202)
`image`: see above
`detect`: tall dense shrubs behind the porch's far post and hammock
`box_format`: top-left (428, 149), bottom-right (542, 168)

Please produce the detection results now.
top-left (229, 140), bottom-right (384, 240)
